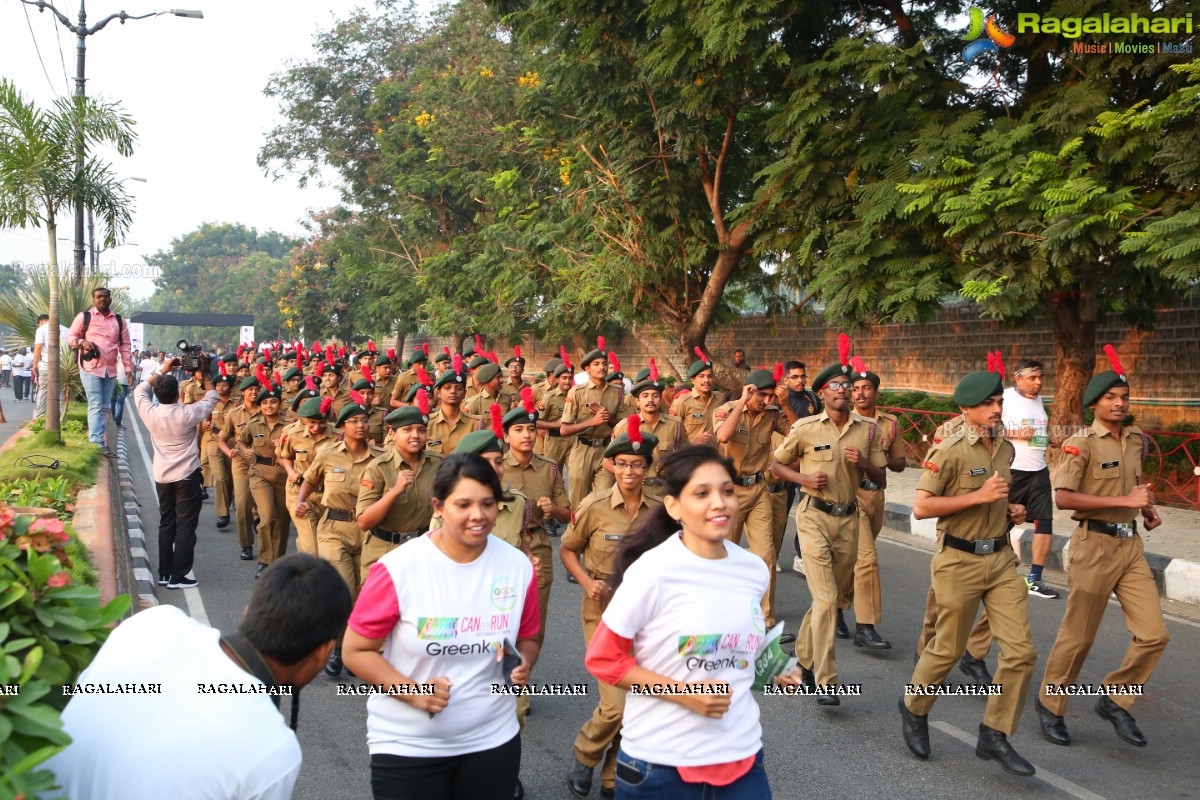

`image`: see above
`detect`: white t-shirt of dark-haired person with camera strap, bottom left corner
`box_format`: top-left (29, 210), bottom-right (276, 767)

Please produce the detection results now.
top-left (46, 606), bottom-right (300, 800)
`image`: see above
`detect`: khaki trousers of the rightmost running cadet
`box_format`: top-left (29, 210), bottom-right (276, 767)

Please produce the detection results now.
top-left (1040, 527), bottom-right (1168, 716)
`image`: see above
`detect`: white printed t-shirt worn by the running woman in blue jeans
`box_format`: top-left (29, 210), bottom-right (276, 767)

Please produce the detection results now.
top-left (604, 536), bottom-right (770, 766)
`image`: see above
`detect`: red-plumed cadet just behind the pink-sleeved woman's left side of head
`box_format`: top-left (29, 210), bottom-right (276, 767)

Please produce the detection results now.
top-left (355, 389), bottom-right (442, 582)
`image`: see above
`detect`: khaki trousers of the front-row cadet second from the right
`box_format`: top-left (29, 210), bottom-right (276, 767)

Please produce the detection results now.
top-left (905, 542), bottom-right (1037, 736)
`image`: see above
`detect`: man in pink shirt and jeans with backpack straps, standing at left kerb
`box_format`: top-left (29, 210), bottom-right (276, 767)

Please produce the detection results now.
top-left (67, 287), bottom-right (133, 457)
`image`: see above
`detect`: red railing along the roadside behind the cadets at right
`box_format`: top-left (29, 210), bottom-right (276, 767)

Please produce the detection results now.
top-left (881, 407), bottom-right (1200, 511)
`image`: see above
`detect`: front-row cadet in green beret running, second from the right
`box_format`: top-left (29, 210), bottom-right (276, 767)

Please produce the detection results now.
top-left (902, 372), bottom-right (1037, 776)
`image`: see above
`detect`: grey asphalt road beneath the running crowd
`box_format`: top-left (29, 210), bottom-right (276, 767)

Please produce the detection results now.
top-left (126, 413), bottom-right (1200, 800)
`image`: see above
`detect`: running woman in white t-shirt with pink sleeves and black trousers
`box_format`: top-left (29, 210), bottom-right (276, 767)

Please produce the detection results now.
top-left (342, 453), bottom-right (540, 800)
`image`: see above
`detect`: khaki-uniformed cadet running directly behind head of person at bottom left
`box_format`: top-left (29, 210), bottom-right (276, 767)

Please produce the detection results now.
top-left (295, 402), bottom-right (383, 678)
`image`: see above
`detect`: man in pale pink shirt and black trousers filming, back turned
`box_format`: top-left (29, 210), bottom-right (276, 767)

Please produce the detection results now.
top-left (133, 355), bottom-right (220, 589)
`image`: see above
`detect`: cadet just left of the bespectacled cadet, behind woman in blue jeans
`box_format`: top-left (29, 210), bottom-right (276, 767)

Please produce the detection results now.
top-left (713, 366), bottom-right (798, 633)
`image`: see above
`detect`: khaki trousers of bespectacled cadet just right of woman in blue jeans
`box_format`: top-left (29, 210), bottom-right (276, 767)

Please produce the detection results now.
top-left (796, 495), bottom-right (858, 686)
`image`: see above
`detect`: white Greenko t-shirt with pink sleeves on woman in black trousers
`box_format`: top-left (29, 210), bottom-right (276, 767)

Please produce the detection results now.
top-left (349, 536), bottom-right (540, 757)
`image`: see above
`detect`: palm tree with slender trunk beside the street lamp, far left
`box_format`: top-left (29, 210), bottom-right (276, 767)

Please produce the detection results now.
top-left (0, 78), bottom-right (136, 433)
